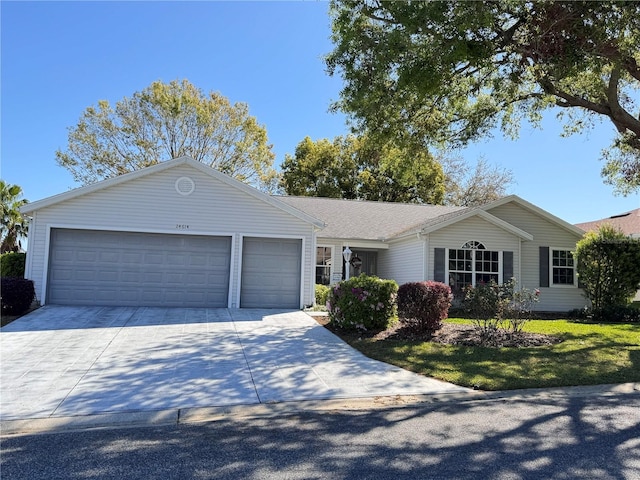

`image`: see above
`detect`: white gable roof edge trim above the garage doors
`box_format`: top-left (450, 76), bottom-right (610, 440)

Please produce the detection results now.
top-left (20, 156), bottom-right (325, 228)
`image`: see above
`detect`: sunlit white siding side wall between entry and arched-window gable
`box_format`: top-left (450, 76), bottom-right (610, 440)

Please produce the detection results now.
top-left (378, 236), bottom-right (425, 285)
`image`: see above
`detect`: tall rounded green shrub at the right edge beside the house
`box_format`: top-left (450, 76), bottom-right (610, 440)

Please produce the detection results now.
top-left (575, 224), bottom-right (640, 310)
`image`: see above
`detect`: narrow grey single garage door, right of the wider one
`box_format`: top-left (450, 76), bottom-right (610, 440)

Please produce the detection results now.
top-left (240, 237), bottom-right (302, 308)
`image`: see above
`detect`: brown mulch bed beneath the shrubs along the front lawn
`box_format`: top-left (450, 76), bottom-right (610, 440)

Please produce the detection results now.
top-left (314, 317), bottom-right (562, 348)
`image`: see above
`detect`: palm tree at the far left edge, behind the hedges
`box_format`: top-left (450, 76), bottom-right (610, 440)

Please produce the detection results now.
top-left (0, 180), bottom-right (29, 253)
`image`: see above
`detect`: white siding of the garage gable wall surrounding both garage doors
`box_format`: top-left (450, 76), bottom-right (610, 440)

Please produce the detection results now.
top-left (27, 165), bottom-right (315, 307)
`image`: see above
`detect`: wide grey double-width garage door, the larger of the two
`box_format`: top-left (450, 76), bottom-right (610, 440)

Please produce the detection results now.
top-left (47, 229), bottom-right (231, 307)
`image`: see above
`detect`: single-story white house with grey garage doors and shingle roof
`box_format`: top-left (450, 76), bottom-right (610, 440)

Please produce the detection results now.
top-left (21, 157), bottom-right (586, 311)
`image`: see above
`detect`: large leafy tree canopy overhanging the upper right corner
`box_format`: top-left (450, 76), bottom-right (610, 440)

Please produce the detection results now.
top-left (327, 0), bottom-right (640, 194)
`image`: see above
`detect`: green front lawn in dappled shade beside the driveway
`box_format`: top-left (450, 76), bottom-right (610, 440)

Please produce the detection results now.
top-left (336, 319), bottom-right (640, 390)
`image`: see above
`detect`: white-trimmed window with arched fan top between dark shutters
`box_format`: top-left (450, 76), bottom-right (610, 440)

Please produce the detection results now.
top-left (448, 241), bottom-right (500, 292)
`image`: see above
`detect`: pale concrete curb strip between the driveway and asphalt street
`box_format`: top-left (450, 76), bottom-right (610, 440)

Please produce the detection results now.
top-left (0, 382), bottom-right (640, 437)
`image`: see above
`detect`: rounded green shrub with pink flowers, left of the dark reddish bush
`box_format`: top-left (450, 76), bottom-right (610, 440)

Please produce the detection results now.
top-left (327, 274), bottom-right (398, 330)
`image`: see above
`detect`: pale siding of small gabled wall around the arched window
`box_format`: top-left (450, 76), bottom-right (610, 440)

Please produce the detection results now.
top-left (428, 217), bottom-right (526, 286)
